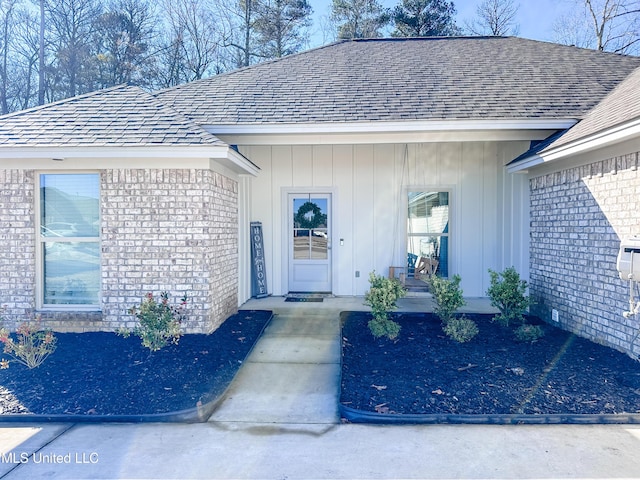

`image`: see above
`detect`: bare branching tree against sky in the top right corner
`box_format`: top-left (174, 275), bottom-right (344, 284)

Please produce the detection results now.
top-left (553, 0), bottom-right (640, 54)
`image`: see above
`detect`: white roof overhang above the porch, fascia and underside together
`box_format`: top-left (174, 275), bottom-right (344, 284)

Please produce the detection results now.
top-left (203, 118), bottom-right (576, 145)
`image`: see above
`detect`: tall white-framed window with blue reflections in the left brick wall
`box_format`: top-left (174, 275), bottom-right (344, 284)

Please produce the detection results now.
top-left (38, 173), bottom-right (100, 308)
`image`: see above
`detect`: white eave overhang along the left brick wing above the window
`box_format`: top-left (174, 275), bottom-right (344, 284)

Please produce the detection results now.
top-left (0, 144), bottom-right (260, 176)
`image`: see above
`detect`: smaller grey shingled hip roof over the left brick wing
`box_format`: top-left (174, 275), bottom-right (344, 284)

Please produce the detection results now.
top-left (0, 86), bottom-right (225, 147)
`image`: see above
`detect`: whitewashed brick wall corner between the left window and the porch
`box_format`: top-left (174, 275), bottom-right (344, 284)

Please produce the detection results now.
top-left (101, 169), bottom-right (238, 332)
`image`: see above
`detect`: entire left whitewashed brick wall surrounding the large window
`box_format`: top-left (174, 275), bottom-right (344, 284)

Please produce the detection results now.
top-left (0, 169), bottom-right (238, 333)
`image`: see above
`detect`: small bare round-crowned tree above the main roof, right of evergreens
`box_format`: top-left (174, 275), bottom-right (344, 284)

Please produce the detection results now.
top-left (466, 0), bottom-right (520, 36)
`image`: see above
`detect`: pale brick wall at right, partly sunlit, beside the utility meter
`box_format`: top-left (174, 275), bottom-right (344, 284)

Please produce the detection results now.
top-left (530, 153), bottom-right (640, 356)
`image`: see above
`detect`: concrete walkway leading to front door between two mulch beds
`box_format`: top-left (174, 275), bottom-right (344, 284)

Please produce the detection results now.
top-left (210, 299), bottom-right (340, 428)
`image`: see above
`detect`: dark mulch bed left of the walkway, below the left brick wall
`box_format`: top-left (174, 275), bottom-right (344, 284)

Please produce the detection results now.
top-left (0, 311), bottom-right (271, 420)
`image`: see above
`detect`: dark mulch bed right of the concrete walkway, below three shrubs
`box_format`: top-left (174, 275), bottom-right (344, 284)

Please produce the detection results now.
top-left (340, 312), bottom-right (640, 415)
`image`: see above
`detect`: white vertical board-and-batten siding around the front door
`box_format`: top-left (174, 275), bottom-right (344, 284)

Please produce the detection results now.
top-left (240, 142), bottom-right (529, 300)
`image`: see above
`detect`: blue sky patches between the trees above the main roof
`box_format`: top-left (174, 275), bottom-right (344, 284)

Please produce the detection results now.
top-left (308, 0), bottom-right (571, 46)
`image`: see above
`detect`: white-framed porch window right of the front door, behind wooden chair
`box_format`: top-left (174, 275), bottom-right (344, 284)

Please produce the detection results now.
top-left (407, 191), bottom-right (450, 277)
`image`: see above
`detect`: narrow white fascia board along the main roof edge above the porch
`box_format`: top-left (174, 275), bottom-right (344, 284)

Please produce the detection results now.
top-left (203, 118), bottom-right (576, 135)
